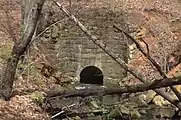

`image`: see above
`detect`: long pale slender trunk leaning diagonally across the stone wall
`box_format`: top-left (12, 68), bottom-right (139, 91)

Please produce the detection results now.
top-left (53, 0), bottom-right (181, 110)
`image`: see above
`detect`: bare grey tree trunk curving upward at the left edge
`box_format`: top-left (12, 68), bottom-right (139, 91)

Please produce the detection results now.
top-left (0, 0), bottom-right (45, 100)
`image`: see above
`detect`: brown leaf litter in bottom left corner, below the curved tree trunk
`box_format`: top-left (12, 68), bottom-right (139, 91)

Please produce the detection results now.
top-left (0, 95), bottom-right (49, 120)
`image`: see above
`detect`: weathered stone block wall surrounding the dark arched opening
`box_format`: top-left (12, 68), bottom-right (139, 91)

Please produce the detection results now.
top-left (34, 8), bottom-right (128, 84)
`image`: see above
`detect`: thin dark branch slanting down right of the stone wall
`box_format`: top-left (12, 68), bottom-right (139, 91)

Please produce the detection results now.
top-left (113, 25), bottom-right (181, 101)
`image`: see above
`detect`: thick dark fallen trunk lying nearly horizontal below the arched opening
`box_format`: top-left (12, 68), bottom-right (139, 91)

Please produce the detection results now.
top-left (47, 76), bottom-right (181, 99)
